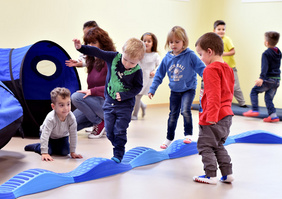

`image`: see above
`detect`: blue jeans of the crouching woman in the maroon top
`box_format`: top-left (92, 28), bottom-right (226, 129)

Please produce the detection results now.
top-left (71, 92), bottom-right (105, 131)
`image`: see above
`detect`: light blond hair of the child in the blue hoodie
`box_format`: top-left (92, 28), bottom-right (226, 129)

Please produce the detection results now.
top-left (165, 26), bottom-right (189, 49)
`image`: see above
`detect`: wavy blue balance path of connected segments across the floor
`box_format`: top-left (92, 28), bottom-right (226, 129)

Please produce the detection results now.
top-left (0, 130), bottom-right (282, 199)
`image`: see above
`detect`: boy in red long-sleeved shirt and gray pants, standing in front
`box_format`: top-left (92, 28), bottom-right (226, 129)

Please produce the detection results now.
top-left (193, 33), bottom-right (234, 184)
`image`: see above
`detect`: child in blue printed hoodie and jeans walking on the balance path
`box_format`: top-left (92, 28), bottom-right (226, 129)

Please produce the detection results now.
top-left (148, 26), bottom-right (205, 149)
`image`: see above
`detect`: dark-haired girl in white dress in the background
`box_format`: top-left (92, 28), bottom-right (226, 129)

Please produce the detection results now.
top-left (131, 32), bottom-right (160, 120)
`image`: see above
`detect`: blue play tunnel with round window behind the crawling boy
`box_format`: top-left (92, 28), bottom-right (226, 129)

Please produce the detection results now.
top-left (0, 40), bottom-right (81, 137)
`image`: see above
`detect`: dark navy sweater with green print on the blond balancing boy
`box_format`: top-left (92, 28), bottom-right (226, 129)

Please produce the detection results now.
top-left (78, 45), bottom-right (143, 106)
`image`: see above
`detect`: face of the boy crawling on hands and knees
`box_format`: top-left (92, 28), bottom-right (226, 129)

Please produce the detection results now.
top-left (51, 95), bottom-right (71, 121)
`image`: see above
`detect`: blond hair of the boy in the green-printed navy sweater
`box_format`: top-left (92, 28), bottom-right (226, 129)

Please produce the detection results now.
top-left (122, 38), bottom-right (146, 60)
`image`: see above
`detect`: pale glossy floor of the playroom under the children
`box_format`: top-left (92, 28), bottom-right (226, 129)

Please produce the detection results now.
top-left (0, 106), bottom-right (282, 199)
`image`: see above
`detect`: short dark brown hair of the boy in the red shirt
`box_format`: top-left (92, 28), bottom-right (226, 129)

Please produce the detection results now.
top-left (195, 32), bottom-right (224, 55)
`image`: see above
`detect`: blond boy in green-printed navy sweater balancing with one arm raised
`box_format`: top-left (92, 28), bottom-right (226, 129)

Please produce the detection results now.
top-left (73, 38), bottom-right (146, 163)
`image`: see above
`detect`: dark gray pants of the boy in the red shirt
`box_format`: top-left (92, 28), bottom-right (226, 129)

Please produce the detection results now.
top-left (197, 115), bottom-right (232, 177)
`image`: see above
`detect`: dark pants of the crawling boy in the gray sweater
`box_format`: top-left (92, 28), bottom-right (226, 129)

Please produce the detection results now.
top-left (34, 136), bottom-right (70, 156)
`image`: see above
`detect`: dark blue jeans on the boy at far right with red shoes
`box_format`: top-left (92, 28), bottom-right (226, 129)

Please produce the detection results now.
top-left (250, 79), bottom-right (280, 115)
